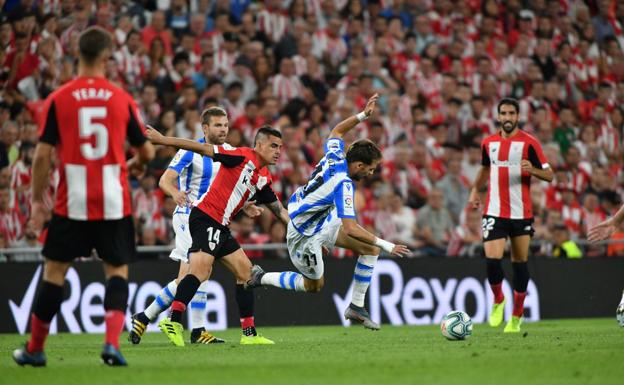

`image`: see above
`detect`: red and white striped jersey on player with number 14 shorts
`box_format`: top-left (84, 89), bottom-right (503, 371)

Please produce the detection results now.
top-left (197, 146), bottom-right (277, 226)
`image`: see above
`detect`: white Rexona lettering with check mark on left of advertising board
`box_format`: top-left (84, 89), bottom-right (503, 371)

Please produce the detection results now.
top-left (9, 267), bottom-right (227, 334)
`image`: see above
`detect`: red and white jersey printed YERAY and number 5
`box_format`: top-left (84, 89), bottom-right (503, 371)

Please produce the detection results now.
top-left (39, 77), bottom-right (147, 221)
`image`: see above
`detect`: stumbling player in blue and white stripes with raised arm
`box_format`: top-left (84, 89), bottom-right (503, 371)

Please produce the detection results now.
top-left (246, 94), bottom-right (409, 330)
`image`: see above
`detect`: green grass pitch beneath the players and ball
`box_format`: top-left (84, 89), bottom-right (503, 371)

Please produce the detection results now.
top-left (0, 318), bottom-right (624, 385)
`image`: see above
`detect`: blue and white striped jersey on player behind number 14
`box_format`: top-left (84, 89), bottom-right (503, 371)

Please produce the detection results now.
top-left (168, 138), bottom-right (233, 214)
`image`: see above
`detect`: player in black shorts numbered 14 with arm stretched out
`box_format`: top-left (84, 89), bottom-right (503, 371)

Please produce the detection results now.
top-left (147, 126), bottom-right (289, 346)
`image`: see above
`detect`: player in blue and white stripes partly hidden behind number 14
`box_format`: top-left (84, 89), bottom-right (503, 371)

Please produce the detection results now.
top-left (128, 107), bottom-right (261, 344)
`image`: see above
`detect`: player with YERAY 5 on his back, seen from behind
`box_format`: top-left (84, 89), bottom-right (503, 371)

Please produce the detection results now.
top-left (13, 27), bottom-right (154, 366)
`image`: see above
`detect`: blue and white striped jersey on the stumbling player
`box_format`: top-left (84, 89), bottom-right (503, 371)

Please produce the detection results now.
top-left (288, 138), bottom-right (355, 236)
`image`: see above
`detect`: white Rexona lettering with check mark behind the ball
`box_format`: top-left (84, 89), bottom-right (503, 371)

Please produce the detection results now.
top-left (333, 259), bottom-right (540, 326)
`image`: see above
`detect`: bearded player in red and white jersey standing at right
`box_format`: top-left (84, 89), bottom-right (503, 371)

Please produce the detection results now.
top-left (469, 98), bottom-right (553, 333)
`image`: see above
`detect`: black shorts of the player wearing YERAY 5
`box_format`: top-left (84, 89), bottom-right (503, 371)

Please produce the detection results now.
top-left (41, 214), bottom-right (136, 266)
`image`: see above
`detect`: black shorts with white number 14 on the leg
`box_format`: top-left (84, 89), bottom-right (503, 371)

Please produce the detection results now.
top-left (188, 207), bottom-right (240, 259)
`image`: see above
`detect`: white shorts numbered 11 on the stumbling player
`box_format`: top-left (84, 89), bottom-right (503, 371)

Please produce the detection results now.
top-left (286, 213), bottom-right (342, 279)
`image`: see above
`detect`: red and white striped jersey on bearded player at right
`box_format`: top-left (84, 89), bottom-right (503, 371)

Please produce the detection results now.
top-left (481, 130), bottom-right (550, 219)
